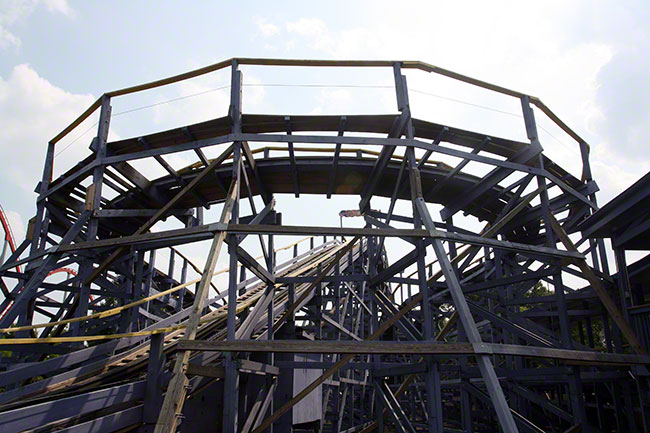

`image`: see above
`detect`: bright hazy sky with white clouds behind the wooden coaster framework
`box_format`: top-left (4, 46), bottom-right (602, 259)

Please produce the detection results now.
top-left (0, 0), bottom-right (650, 290)
